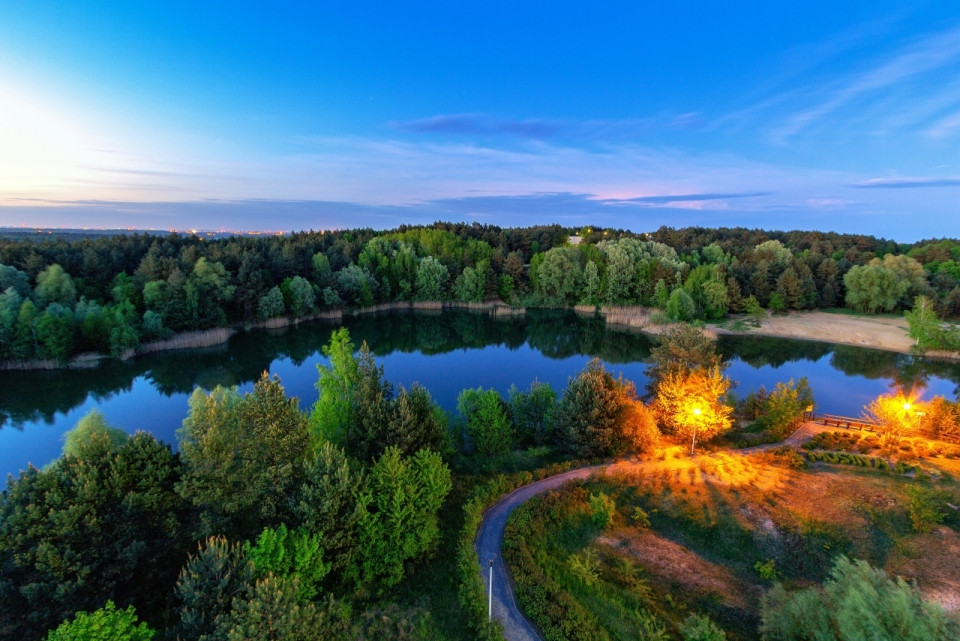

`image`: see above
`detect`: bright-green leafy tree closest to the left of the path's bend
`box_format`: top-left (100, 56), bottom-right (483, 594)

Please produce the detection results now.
top-left (355, 448), bottom-right (452, 586)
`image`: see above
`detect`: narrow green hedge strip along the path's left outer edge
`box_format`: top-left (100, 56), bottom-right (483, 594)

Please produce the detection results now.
top-left (457, 461), bottom-right (589, 641)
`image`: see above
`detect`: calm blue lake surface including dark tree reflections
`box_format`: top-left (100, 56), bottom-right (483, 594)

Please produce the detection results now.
top-left (0, 310), bottom-right (960, 477)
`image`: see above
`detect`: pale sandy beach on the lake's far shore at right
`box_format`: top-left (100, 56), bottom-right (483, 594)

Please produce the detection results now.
top-left (710, 311), bottom-right (913, 354)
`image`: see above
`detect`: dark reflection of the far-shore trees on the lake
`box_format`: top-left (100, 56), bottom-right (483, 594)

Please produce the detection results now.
top-left (0, 310), bottom-right (960, 426)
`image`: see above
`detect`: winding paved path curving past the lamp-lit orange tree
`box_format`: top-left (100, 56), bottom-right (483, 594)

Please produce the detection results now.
top-left (474, 421), bottom-right (830, 641)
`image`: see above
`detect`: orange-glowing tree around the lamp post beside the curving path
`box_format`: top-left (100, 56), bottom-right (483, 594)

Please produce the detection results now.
top-left (654, 366), bottom-right (733, 455)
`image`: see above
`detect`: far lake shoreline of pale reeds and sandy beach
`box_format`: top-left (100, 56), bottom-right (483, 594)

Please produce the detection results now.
top-left (0, 301), bottom-right (960, 371)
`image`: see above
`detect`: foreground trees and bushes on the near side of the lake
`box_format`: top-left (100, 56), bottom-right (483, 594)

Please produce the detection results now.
top-left (0, 324), bottom-right (960, 641)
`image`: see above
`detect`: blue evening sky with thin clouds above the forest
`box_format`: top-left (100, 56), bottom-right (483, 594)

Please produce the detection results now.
top-left (0, 0), bottom-right (960, 241)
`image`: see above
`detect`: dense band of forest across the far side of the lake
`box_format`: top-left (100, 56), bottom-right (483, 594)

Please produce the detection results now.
top-left (0, 223), bottom-right (960, 361)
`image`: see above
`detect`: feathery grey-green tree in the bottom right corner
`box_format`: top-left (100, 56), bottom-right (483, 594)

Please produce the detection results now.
top-left (760, 556), bottom-right (960, 641)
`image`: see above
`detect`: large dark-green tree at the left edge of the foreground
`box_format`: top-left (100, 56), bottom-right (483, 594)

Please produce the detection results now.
top-left (0, 432), bottom-right (190, 639)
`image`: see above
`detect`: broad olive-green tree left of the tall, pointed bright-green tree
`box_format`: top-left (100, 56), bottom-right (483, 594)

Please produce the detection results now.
top-left (177, 372), bottom-right (310, 536)
